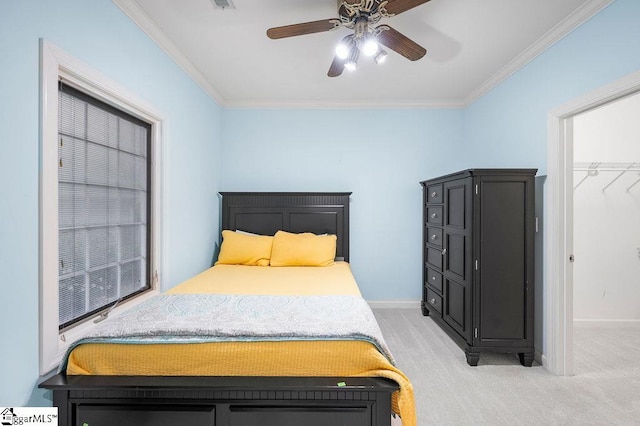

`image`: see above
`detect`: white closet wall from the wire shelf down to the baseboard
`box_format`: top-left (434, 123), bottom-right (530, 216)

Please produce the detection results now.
top-left (573, 161), bottom-right (640, 322)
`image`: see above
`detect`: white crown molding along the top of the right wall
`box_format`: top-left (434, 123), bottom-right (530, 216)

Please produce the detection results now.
top-left (462, 0), bottom-right (615, 107)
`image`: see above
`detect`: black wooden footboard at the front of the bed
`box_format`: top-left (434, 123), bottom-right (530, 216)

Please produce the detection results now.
top-left (40, 374), bottom-right (398, 426)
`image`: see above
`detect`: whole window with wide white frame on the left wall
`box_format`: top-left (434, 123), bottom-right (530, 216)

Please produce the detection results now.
top-left (39, 41), bottom-right (162, 374)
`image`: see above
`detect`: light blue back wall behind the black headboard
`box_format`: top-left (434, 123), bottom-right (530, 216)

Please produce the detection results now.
top-left (222, 109), bottom-right (463, 300)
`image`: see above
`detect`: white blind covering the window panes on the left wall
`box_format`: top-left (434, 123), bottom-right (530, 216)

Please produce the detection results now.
top-left (58, 83), bottom-right (151, 329)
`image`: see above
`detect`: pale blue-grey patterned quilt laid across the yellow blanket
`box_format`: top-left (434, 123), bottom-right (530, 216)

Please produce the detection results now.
top-left (60, 294), bottom-right (395, 371)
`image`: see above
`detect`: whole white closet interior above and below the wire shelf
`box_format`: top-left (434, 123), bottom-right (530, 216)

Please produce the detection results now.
top-left (572, 93), bottom-right (640, 325)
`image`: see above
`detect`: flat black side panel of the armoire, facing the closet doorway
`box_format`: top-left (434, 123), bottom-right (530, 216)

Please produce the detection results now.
top-left (475, 176), bottom-right (534, 347)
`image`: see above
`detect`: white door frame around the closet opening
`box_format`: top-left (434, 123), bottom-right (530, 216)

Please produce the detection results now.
top-left (543, 71), bottom-right (640, 376)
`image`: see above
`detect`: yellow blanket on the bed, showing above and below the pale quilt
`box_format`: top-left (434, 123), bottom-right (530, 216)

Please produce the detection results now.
top-left (66, 262), bottom-right (416, 426)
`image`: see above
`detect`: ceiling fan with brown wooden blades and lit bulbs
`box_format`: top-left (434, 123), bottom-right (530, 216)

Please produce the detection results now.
top-left (267, 0), bottom-right (429, 77)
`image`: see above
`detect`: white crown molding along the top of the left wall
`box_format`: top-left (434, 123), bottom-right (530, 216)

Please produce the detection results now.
top-left (112, 0), bottom-right (225, 106)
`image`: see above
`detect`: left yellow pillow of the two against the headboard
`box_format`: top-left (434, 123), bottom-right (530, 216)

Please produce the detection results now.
top-left (216, 230), bottom-right (273, 266)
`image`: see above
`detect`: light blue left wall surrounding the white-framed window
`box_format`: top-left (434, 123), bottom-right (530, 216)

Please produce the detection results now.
top-left (0, 0), bottom-right (222, 406)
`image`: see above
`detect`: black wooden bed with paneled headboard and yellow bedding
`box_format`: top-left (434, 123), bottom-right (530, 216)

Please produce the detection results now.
top-left (40, 192), bottom-right (416, 426)
